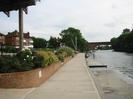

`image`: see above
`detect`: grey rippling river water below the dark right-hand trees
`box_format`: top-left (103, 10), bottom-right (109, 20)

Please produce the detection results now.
top-left (93, 50), bottom-right (133, 79)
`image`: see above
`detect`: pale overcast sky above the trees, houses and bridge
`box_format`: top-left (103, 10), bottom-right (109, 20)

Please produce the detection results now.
top-left (0, 0), bottom-right (133, 42)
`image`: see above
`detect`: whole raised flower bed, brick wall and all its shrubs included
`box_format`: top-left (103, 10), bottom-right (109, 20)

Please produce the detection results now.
top-left (0, 47), bottom-right (73, 88)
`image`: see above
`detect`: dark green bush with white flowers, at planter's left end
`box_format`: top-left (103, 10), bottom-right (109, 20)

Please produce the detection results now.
top-left (0, 50), bottom-right (34, 73)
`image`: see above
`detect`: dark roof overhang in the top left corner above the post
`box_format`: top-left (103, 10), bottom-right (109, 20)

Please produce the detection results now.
top-left (0, 0), bottom-right (40, 12)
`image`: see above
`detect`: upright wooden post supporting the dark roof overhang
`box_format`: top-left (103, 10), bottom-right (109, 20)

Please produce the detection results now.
top-left (19, 8), bottom-right (23, 51)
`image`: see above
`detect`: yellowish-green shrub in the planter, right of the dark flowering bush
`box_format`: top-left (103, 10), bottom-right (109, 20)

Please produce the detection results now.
top-left (37, 51), bottom-right (58, 67)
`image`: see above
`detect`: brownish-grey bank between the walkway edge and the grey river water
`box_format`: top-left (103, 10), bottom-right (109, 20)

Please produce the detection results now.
top-left (88, 59), bottom-right (133, 99)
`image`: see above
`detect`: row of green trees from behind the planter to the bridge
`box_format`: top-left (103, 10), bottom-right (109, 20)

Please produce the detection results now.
top-left (32, 27), bottom-right (89, 52)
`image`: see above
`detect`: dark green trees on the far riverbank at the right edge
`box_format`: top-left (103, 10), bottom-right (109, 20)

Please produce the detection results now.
top-left (111, 29), bottom-right (133, 53)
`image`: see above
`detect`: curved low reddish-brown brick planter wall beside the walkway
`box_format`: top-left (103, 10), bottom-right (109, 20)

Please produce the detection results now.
top-left (0, 57), bottom-right (71, 88)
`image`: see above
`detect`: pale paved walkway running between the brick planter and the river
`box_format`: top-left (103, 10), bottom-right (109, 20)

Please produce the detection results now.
top-left (0, 54), bottom-right (101, 99)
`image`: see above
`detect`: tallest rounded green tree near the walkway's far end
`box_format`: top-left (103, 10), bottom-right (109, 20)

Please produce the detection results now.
top-left (60, 27), bottom-right (88, 51)
